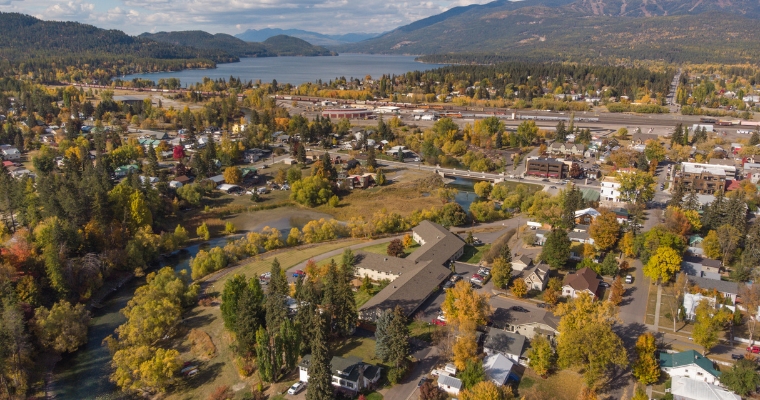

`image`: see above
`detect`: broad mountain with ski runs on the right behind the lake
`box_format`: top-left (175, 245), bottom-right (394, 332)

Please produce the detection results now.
top-left (334, 0), bottom-right (760, 63)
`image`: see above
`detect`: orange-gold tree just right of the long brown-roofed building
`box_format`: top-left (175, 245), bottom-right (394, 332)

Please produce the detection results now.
top-left (441, 280), bottom-right (491, 332)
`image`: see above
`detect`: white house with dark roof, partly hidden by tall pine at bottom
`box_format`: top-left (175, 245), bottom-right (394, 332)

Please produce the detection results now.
top-left (298, 354), bottom-right (382, 393)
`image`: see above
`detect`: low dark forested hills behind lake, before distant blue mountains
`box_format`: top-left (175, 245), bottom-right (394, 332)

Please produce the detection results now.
top-left (139, 31), bottom-right (337, 57)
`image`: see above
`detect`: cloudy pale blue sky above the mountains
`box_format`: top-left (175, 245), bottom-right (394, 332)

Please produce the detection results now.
top-left (0, 0), bottom-right (491, 35)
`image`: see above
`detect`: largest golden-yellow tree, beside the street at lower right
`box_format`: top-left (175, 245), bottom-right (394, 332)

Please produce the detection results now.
top-left (555, 293), bottom-right (628, 389)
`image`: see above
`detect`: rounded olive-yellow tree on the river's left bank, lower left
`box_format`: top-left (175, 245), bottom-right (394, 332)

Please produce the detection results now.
top-left (34, 300), bottom-right (90, 353)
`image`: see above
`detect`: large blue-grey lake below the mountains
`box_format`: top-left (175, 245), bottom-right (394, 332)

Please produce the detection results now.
top-left (121, 54), bottom-right (445, 86)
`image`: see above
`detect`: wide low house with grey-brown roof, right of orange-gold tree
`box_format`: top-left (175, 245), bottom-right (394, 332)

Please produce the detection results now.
top-left (491, 308), bottom-right (559, 341)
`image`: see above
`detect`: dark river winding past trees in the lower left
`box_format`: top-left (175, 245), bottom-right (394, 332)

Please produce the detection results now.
top-left (54, 235), bottom-right (240, 400)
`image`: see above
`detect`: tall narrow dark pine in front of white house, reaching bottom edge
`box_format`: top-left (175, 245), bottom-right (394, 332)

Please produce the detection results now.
top-left (306, 312), bottom-right (333, 400)
